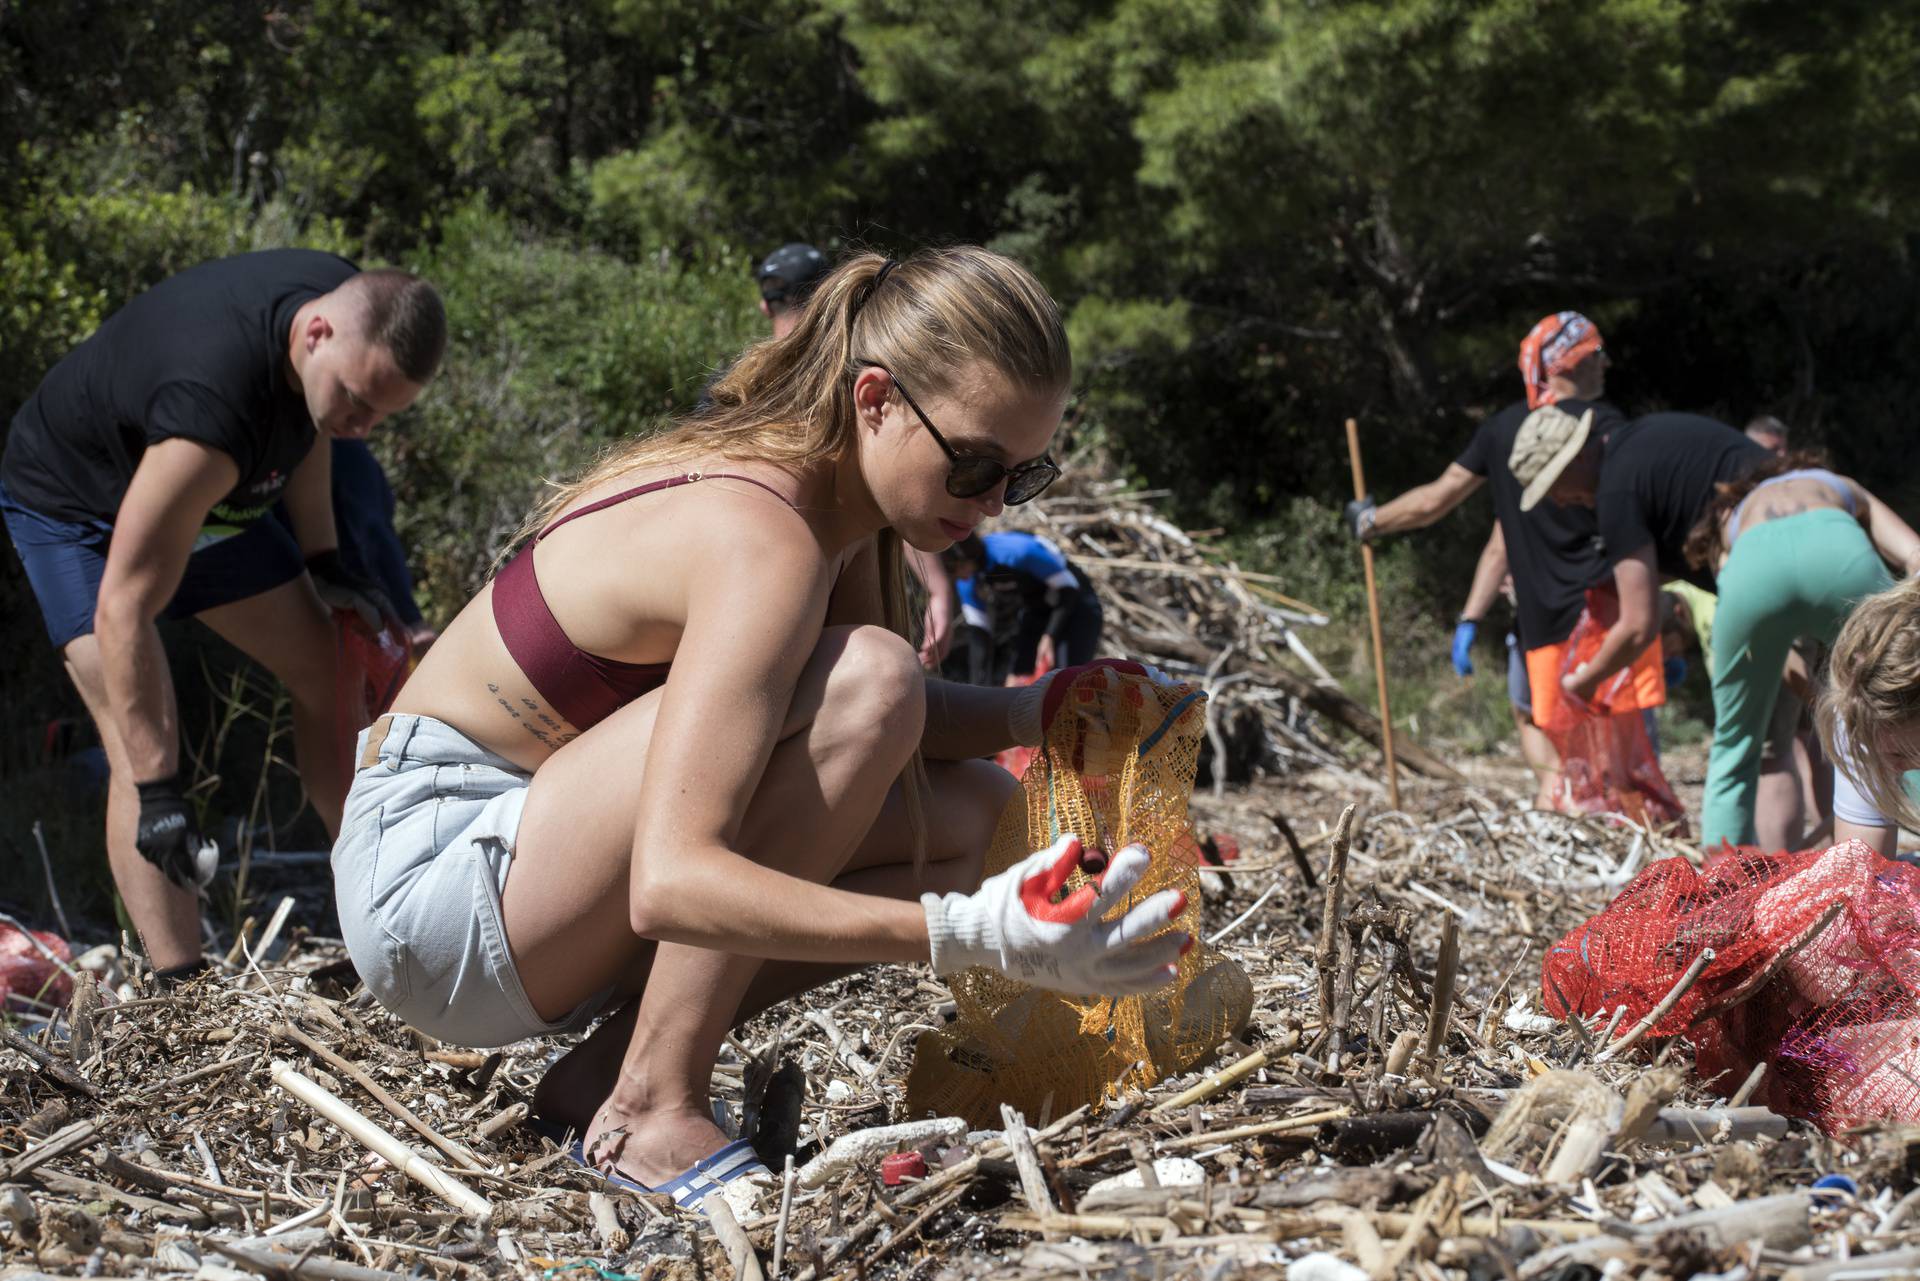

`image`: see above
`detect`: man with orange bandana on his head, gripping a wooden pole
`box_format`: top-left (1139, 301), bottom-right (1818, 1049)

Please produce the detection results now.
top-left (1348, 311), bottom-right (1624, 805)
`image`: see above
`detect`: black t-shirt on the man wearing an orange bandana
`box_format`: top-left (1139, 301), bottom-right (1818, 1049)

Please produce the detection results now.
top-left (1453, 399), bottom-right (1626, 649)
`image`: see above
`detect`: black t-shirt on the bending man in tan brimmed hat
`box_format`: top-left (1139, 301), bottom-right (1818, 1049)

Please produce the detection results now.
top-left (1597, 413), bottom-right (1766, 592)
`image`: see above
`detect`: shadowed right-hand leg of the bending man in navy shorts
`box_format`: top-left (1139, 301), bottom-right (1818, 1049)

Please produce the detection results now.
top-left (194, 574), bottom-right (367, 837)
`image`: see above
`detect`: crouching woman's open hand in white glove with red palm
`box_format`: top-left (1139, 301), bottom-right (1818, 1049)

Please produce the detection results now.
top-left (920, 834), bottom-right (1194, 997)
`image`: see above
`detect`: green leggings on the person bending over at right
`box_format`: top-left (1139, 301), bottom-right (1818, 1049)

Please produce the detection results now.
top-left (1701, 507), bottom-right (1893, 849)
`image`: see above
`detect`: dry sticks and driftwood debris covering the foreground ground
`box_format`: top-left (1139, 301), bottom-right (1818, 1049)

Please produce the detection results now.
top-left (0, 774), bottom-right (1920, 1281)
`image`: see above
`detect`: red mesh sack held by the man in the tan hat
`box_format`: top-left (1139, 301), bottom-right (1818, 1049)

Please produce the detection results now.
top-left (1542, 588), bottom-right (1686, 835)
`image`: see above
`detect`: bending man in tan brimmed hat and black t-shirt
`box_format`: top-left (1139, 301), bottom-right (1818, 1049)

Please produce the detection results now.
top-left (1509, 413), bottom-right (1768, 699)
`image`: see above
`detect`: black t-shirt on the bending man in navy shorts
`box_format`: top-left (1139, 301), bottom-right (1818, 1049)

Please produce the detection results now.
top-left (0, 250), bottom-right (359, 532)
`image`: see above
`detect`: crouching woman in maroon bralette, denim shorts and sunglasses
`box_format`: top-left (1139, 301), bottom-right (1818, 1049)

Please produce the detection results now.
top-left (334, 248), bottom-right (1190, 1202)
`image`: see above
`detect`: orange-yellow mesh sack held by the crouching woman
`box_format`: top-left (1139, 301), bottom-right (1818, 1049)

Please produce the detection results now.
top-left (906, 666), bottom-right (1254, 1125)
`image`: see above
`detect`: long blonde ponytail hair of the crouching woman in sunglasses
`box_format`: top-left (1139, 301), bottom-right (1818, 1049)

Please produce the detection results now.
top-left (515, 246), bottom-right (1073, 864)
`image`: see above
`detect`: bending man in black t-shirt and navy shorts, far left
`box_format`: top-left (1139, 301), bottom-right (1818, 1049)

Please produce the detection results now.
top-left (0, 250), bottom-right (447, 976)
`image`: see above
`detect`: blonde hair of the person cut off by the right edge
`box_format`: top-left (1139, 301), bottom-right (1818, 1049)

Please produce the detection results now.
top-left (1816, 578), bottom-right (1920, 830)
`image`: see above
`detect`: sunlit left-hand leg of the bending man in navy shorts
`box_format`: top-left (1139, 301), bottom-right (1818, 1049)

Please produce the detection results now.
top-left (61, 632), bottom-right (200, 970)
